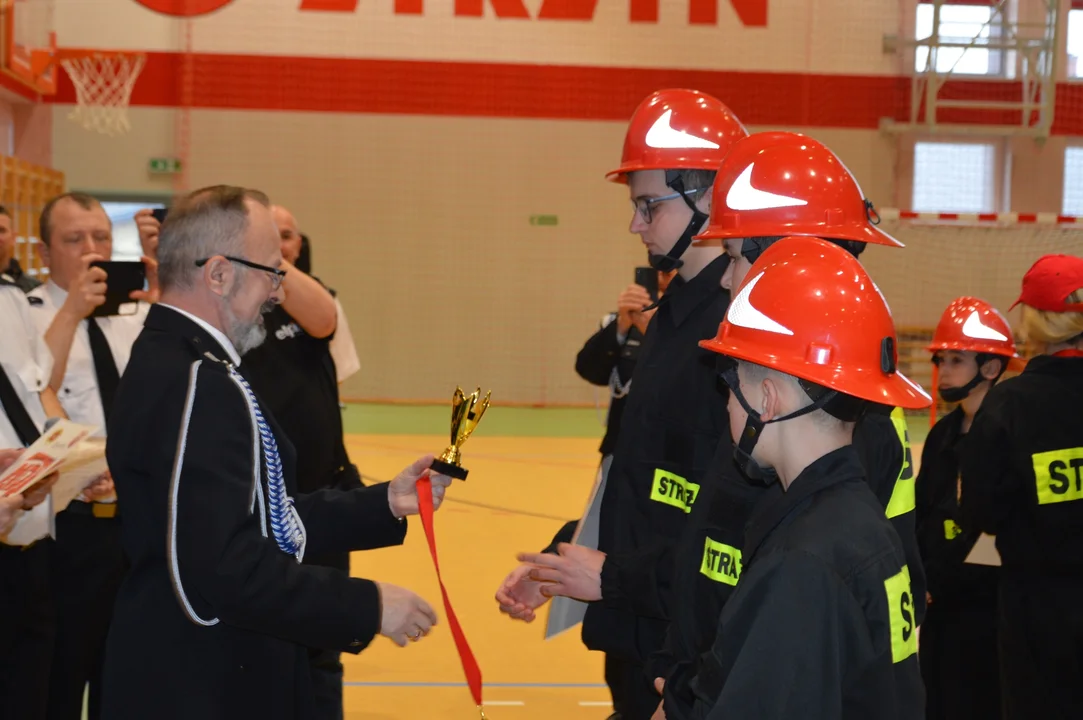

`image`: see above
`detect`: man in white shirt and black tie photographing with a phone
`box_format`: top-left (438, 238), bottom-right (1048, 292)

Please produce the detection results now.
top-left (27, 193), bottom-right (156, 720)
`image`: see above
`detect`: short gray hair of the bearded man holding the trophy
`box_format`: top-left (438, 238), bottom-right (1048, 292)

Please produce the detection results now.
top-left (158, 185), bottom-right (271, 291)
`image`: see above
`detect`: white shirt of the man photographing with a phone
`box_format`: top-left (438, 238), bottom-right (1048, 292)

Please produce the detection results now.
top-left (27, 280), bottom-right (151, 437)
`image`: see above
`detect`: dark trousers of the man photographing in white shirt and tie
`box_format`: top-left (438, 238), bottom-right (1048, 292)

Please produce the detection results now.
top-left (48, 501), bottom-right (125, 720)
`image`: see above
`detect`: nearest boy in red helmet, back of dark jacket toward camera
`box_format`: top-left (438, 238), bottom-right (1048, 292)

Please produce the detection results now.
top-left (692, 237), bottom-right (931, 720)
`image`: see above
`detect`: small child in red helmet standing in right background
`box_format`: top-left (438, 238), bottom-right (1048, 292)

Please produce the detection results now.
top-left (915, 297), bottom-right (1022, 720)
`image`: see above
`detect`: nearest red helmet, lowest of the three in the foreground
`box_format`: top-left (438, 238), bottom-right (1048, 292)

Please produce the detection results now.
top-left (700, 232), bottom-right (932, 409)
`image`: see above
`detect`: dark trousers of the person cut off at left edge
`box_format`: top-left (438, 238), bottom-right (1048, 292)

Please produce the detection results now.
top-left (0, 538), bottom-right (55, 720)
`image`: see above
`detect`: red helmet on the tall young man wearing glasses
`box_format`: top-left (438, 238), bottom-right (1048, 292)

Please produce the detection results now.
top-left (605, 89), bottom-right (748, 183)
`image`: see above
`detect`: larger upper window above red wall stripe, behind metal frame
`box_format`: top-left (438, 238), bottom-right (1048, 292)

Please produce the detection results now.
top-left (914, 3), bottom-right (1001, 75)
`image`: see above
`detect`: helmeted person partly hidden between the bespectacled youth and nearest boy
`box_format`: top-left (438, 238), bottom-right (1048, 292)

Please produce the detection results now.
top-left (651, 132), bottom-right (924, 720)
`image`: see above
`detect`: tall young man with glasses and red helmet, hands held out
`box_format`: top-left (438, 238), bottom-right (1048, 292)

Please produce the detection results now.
top-left (497, 90), bottom-right (747, 720)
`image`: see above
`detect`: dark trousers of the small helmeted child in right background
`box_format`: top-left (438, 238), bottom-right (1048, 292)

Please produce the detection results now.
top-left (918, 599), bottom-right (1001, 720)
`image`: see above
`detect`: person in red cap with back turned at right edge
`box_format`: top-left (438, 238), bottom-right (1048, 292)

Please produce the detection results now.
top-left (966, 254), bottom-right (1083, 720)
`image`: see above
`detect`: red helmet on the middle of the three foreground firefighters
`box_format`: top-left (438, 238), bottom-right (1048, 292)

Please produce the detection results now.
top-left (694, 132), bottom-right (904, 248)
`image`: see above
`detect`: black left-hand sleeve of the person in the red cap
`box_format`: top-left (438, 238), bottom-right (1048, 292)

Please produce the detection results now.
top-left (960, 396), bottom-right (1018, 535)
